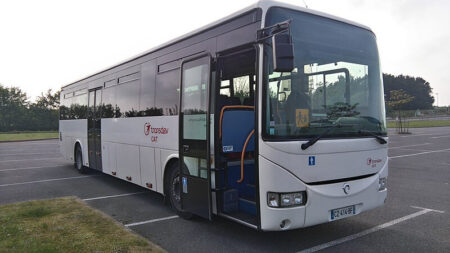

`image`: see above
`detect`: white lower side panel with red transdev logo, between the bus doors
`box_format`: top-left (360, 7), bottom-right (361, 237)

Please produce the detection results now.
top-left (101, 116), bottom-right (178, 193)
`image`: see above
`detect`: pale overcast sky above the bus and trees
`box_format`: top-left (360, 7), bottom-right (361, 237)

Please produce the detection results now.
top-left (0, 0), bottom-right (450, 106)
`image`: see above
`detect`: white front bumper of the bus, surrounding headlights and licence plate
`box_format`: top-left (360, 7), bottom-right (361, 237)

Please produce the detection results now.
top-left (259, 155), bottom-right (388, 231)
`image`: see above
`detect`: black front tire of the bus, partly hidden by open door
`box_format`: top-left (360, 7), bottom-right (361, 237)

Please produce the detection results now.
top-left (165, 162), bottom-right (193, 220)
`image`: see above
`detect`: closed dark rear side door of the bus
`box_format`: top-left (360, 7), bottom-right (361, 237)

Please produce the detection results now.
top-left (88, 88), bottom-right (102, 170)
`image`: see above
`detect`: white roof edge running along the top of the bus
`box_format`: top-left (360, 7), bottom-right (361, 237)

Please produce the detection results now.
top-left (62, 0), bottom-right (372, 89)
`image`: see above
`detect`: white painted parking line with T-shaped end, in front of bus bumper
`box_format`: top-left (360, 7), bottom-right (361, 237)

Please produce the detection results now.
top-left (297, 206), bottom-right (444, 253)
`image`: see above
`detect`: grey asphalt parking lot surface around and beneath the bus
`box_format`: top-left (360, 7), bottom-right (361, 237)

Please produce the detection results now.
top-left (0, 127), bottom-right (450, 252)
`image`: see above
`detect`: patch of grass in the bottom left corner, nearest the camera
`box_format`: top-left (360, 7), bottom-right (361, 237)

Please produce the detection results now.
top-left (0, 197), bottom-right (164, 253)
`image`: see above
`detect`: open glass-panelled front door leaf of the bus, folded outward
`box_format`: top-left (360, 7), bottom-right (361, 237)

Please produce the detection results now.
top-left (179, 56), bottom-right (211, 219)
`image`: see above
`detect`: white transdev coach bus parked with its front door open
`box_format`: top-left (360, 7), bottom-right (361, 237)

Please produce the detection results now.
top-left (59, 1), bottom-right (388, 231)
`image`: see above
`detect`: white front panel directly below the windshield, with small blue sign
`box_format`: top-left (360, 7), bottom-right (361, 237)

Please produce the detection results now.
top-left (259, 138), bottom-right (387, 182)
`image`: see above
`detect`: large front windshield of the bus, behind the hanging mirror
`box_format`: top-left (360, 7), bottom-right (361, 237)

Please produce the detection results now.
top-left (263, 8), bottom-right (386, 139)
